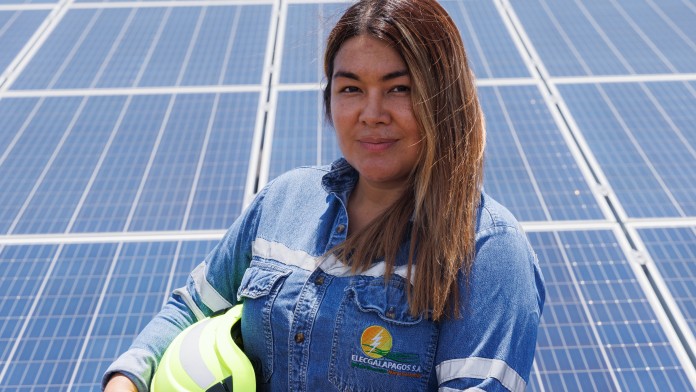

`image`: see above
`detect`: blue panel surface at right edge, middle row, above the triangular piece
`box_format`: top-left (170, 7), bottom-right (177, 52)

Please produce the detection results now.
top-left (559, 82), bottom-right (696, 218)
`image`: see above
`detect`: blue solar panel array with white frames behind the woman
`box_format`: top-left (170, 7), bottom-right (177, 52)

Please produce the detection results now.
top-left (0, 0), bottom-right (696, 391)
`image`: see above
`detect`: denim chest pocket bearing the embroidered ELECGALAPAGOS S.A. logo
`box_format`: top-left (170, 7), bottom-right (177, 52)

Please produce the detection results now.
top-left (329, 277), bottom-right (438, 392)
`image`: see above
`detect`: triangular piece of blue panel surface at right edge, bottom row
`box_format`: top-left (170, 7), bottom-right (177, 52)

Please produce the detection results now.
top-left (638, 227), bottom-right (696, 335)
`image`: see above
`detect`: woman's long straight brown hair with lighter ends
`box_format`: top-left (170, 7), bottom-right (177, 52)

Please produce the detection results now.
top-left (324, 0), bottom-right (485, 320)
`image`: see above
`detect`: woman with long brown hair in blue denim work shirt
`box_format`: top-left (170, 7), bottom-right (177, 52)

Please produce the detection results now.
top-left (104, 0), bottom-right (544, 391)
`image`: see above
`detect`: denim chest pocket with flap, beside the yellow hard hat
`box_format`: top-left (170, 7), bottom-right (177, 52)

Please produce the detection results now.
top-left (237, 260), bottom-right (292, 382)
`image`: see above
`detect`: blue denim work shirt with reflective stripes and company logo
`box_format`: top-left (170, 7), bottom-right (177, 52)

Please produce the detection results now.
top-left (104, 159), bottom-right (545, 392)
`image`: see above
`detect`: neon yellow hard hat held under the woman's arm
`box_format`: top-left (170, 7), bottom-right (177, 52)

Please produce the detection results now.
top-left (150, 304), bottom-right (256, 392)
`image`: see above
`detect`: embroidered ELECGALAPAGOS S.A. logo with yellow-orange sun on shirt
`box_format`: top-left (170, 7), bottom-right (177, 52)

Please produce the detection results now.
top-left (351, 325), bottom-right (422, 378)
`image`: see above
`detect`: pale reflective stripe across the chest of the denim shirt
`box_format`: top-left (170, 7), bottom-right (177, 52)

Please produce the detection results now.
top-left (252, 238), bottom-right (413, 279)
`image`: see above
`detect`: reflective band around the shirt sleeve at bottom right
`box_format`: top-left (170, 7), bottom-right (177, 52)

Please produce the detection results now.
top-left (437, 357), bottom-right (526, 392)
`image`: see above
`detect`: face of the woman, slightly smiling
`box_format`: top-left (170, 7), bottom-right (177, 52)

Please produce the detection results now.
top-left (331, 35), bottom-right (422, 188)
